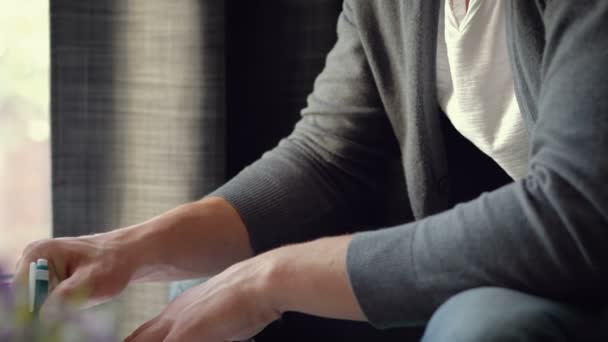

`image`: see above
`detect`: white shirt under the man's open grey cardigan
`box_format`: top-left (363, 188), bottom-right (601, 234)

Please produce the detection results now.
top-left (437, 0), bottom-right (528, 180)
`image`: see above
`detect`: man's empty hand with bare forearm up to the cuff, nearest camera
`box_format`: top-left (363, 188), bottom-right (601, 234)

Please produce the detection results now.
top-left (125, 236), bottom-right (365, 342)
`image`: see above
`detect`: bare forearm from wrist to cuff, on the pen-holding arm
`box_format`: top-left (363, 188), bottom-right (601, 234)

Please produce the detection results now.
top-left (112, 197), bottom-right (253, 281)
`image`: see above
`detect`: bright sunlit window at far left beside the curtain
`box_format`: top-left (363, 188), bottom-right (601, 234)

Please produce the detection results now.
top-left (0, 0), bottom-right (51, 270)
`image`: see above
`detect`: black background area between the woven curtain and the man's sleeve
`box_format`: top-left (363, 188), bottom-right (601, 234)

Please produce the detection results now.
top-left (226, 0), bottom-right (342, 177)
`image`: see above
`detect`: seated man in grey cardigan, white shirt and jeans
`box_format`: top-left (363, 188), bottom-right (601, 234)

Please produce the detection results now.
top-left (17, 0), bottom-right (608, 342)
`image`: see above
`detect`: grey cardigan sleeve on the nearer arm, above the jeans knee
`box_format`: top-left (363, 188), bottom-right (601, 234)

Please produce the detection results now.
top-left (347, 0), bottom-right (608, 328)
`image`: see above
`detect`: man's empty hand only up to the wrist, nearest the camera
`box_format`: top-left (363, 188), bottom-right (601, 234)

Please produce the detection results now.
top-left (125, 254), bottom-right (280, 342)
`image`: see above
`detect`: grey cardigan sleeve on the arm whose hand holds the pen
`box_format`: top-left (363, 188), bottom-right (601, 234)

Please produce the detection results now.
top-left (210, 1), bottom-right (397, 253)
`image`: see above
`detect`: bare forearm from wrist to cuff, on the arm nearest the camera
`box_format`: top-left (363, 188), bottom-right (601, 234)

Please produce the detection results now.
top-left (267, 236), bottom-right (367, 321)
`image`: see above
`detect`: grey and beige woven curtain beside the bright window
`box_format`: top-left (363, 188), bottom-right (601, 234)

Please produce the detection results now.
top-left (51, 0), bottom-right (226, 337)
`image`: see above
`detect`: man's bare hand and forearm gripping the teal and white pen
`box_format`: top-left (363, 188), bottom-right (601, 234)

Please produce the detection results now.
top-left (15, 198), bottom-right (253, 316)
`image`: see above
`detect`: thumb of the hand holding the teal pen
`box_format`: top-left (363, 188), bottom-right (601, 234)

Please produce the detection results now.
top-left (40, 270), bottom-right (90, 322)
